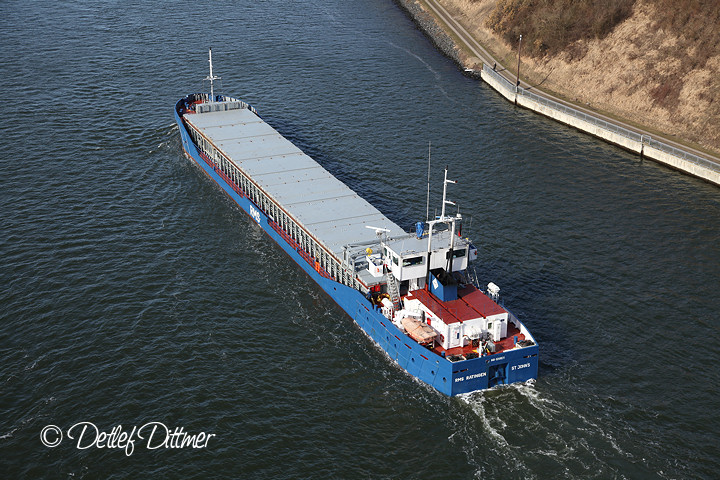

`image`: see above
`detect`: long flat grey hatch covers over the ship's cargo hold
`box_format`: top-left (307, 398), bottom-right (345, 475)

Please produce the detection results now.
top-left (185, 108), bottom-right (407, 258)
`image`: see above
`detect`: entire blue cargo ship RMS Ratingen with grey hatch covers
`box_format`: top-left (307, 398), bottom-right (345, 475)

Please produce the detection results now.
top-left (175, 50), bottom-right (539, 396)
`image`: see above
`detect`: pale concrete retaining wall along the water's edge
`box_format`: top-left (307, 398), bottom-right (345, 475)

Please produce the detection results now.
top-left (481, 65), bottom-right (720, 185)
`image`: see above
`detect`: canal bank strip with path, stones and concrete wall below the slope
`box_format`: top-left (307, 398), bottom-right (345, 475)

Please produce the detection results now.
top-left (395, 0), bottom-right (720, 185)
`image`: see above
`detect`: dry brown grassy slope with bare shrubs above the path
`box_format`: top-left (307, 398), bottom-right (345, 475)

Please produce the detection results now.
top-left (440, 0), bottom-right (720, 152)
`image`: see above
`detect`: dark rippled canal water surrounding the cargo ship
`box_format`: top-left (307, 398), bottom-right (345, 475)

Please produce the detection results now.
top-left (0, 0), bottom-right (720, 479)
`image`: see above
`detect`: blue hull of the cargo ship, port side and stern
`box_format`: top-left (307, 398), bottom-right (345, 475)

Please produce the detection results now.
top-left (175, 95), bottom-right (538, 396)
